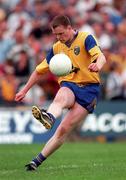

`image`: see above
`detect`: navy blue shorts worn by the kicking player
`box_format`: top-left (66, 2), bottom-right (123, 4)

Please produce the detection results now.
top-left (61, 81), bottom-right (101, 113)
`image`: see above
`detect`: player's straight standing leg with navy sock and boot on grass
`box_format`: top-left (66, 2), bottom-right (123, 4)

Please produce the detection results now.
top-left (27, 103), bottom-right (88, 170)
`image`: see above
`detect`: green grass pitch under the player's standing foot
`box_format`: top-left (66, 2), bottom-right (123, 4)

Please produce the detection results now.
top-left (0, 143), bottom-right (126, 180)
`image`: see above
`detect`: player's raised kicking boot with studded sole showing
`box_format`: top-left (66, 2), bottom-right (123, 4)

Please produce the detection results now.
top-left (32, 106), bottom-right (54, 129)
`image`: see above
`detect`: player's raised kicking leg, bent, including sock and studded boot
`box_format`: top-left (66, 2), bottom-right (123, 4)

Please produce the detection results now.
top-left (32, 87), bottom-right (75, 129)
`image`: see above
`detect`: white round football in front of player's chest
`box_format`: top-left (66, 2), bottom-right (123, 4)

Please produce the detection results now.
top-left (49, 53), bottom-right (72, 76)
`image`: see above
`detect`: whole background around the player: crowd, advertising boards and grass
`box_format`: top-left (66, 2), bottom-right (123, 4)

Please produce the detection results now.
top-left (0, 0), bottom-right (126, 180)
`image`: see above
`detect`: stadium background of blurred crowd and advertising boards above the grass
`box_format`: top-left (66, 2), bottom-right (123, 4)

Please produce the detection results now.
top-left (0, 0), bottom-right (126, 143)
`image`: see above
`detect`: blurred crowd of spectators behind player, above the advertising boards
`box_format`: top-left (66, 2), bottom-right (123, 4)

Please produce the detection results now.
top-left (0, 0), bottom-right (126, 106)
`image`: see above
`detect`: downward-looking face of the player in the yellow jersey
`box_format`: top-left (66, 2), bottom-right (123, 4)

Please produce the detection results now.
top-left (52, 25), bottom-right (71, 43)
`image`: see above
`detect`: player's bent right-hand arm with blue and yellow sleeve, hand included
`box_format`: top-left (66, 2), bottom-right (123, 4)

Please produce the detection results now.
top-left (85, 35), bottom-right (106, 72)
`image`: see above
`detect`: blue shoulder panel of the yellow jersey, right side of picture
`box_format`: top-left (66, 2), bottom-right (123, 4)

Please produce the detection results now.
top-left (85, 35), bottom-right (97, 51)
